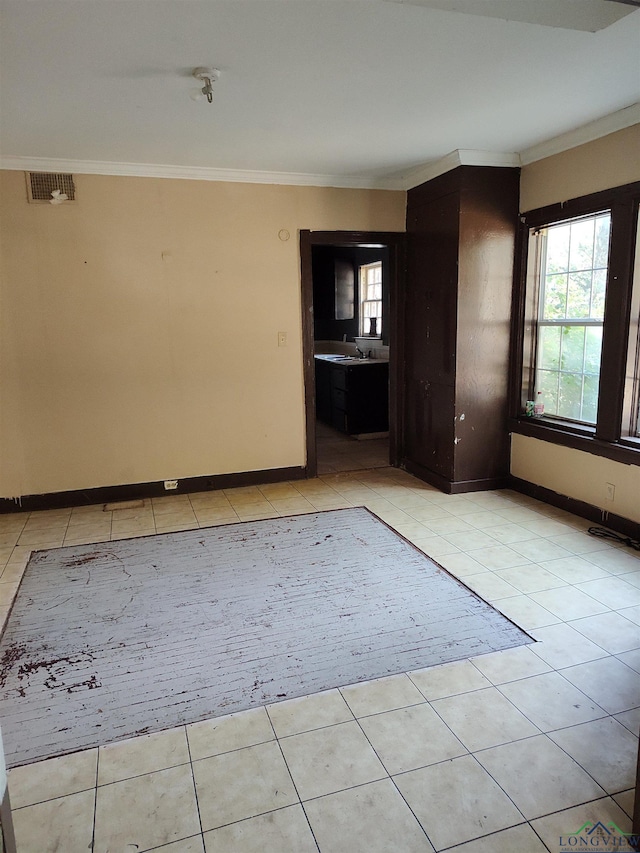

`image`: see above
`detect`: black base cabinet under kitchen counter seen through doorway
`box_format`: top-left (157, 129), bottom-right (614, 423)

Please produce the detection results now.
top-left (315, 358), bottom-right (389, 435)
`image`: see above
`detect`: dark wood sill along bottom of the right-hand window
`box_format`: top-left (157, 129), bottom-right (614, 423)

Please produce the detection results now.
top-left (509, 416), bottom-right (640, 466)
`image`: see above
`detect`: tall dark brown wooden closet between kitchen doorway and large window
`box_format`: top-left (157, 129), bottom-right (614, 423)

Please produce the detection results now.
top-left (402, 166), bottom-right (520, 492)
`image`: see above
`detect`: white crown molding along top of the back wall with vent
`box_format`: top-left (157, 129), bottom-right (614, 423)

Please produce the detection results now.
top-left (0, 155), bottom-right (404, 190)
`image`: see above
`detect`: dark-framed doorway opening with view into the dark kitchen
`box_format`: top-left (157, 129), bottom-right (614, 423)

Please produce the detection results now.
top-left (300, 231), bottom-right (404, 477)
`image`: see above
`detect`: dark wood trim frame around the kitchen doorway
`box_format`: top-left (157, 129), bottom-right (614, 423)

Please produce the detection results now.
top-left (300, 230), bottom-right (406, 477)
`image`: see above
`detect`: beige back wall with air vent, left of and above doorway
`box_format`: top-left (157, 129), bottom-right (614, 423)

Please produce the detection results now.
top-left (0, 171), bottom-right (405, 497)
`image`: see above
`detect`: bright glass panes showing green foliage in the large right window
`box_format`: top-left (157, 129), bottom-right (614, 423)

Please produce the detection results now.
top-left (535, 211), bottom-right (611, 424)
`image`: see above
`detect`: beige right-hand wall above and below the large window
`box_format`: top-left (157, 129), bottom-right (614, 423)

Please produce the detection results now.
top-left (511, 125), bottom-right (640, 522)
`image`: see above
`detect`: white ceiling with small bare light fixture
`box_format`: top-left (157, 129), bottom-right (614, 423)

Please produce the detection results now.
top-left (0, 0), bottom-right (640, 186)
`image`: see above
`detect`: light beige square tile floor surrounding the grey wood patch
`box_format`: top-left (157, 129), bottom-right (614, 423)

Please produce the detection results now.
top-left (0, 468), bottom-right (640, 853)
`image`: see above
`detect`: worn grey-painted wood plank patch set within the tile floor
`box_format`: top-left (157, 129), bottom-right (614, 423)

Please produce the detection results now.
top-left (0, 508), bottom-right (531, 766)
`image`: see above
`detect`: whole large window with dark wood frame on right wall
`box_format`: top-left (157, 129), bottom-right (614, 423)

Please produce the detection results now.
top-left (511, 181), bottom-right (640, 465)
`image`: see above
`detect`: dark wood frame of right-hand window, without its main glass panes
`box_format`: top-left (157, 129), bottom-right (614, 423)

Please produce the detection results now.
top-left (510, 181), bottom-right (640, 465)
